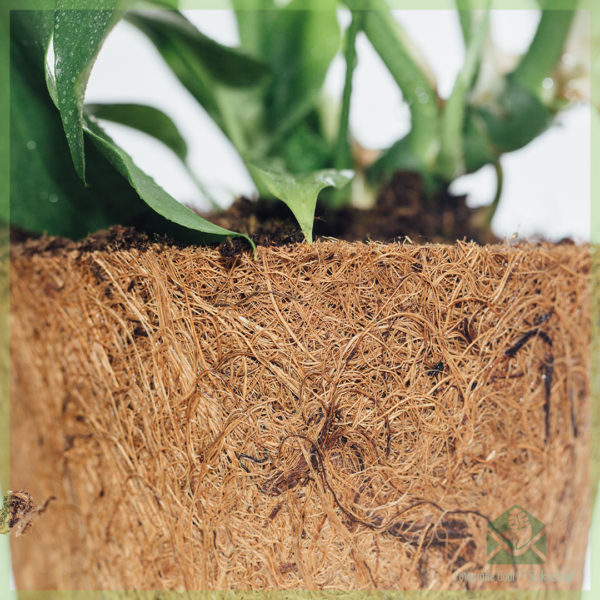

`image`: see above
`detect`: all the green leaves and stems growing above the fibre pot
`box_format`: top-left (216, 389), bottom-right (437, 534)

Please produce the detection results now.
top-left (10, 0), bottom-right (574, 243)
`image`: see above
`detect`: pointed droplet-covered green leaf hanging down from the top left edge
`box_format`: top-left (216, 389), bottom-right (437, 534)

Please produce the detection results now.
top-left (54, 0), bottom-right (124, 181)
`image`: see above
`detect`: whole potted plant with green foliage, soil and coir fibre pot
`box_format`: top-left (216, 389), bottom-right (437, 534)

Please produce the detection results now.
top-left (3, 0), bottom-right (589, 589)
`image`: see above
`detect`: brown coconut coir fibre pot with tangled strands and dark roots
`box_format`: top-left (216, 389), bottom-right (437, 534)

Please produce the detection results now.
top-left (11, 241), bottom-right (590, 589)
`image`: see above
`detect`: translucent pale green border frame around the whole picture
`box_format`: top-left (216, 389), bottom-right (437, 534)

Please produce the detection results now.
top-left (0, 0), bottom-right (600, 600)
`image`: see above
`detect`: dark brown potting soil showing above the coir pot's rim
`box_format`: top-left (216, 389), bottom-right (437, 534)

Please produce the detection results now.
top-left (11, 172), bottom-right (497, 258)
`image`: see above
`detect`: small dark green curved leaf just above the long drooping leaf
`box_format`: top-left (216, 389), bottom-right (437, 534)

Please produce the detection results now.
top-left (85, 104), bottom-right (188, 163)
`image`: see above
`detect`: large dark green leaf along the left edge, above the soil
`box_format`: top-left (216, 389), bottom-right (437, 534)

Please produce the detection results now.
top-left (10, 11), bottom-right (148, 238)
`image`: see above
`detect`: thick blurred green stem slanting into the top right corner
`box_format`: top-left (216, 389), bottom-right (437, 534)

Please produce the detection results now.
top-left (511, 10), bottom-right (575, 96)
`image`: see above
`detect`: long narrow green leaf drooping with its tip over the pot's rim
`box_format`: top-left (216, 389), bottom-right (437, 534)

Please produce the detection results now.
top-left (84, 119), bottom-right (255, 248)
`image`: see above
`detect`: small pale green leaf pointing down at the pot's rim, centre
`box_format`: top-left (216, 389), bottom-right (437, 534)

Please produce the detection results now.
top-left (248, 164), bottom-right (354, 244)
